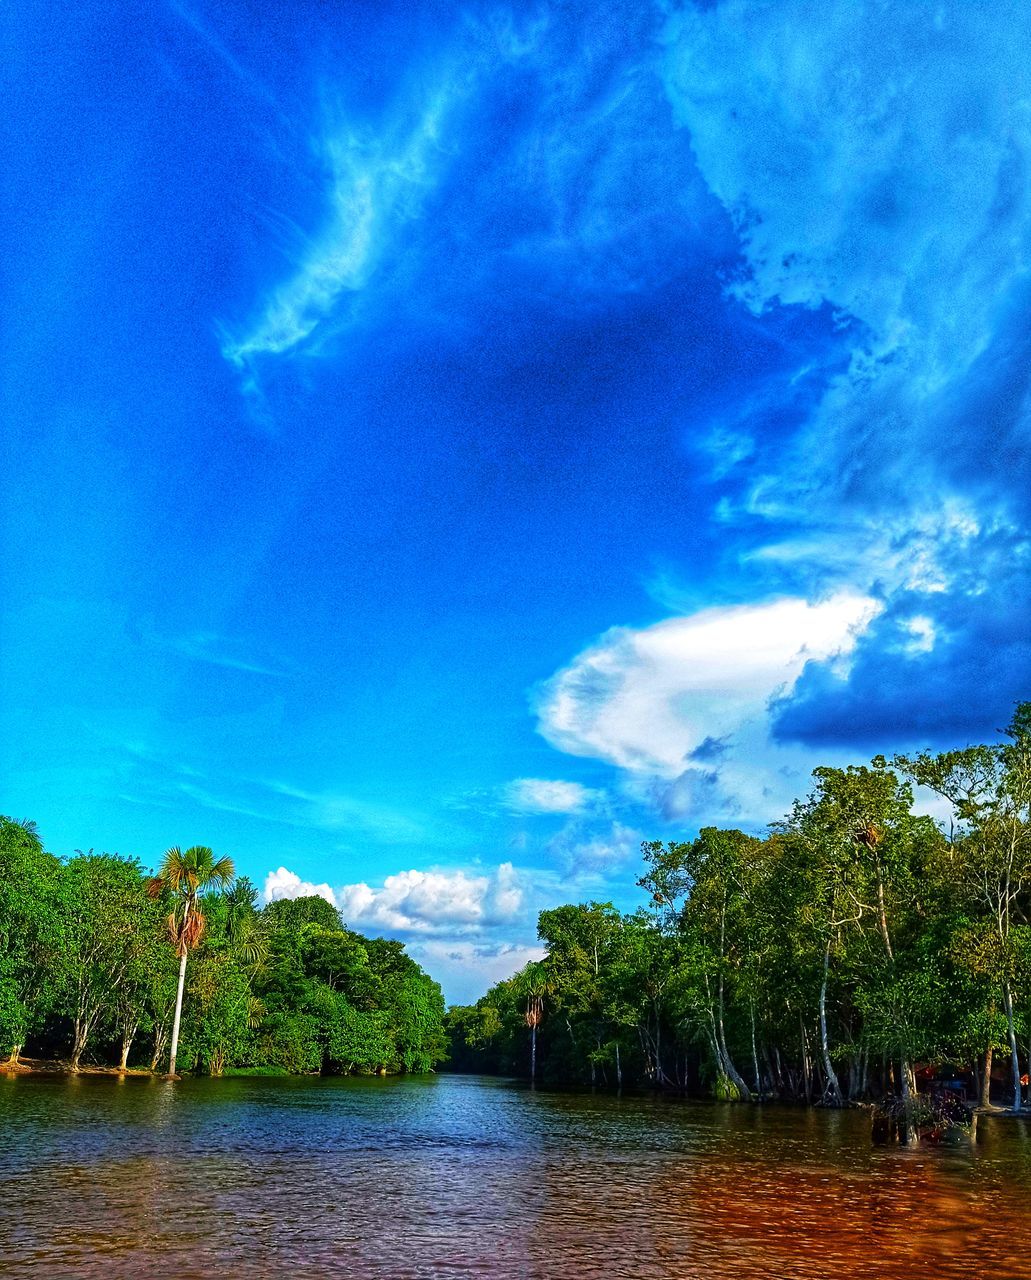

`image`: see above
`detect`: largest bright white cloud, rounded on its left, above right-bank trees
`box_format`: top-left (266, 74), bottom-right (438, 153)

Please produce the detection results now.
top-left (538, 593), bottom-right (880, 824)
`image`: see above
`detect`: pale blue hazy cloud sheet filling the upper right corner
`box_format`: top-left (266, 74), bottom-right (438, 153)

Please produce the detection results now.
top-left (667, 0), bottom-right (1031, 355)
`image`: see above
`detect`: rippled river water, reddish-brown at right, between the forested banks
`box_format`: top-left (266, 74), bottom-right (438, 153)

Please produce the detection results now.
top-left (0, 1075), bottom-right (1031, 1280)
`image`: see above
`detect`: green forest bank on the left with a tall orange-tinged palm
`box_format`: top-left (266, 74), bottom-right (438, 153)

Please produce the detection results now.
top-left (0, 818), bottom-right (446, 1075)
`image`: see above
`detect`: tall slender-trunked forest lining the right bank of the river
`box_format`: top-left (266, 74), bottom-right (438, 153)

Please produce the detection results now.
top-left (448, 703), bottom-right (1031, 1108)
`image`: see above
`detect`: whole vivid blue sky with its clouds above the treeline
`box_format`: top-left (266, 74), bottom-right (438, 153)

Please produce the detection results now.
top-left (8, 0), bottom-right (1031, 1000)
